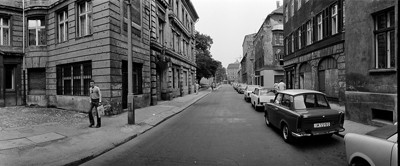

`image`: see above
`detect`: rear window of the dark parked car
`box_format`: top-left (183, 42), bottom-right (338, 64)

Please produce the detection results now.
top-left (293, 94), bottom-right (329, 109)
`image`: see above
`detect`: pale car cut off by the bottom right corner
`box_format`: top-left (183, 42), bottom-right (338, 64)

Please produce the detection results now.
top-left (344, 125), bottom-right (398, 166)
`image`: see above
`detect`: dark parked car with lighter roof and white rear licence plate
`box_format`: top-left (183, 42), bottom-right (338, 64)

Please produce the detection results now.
top-left (264, 89), bottom-right (344, 142)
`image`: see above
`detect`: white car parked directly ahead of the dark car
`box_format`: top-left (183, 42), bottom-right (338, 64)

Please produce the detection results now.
top-left (250, 87), bottom-right (276, 111)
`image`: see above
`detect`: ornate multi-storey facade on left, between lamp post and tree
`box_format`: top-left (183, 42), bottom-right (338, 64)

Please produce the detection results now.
top-left (150, 0), bottom-right (199, 104)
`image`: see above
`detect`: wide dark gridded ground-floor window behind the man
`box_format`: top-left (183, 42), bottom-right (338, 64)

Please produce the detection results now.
top-left (56, 61), bottom-right (92, 96)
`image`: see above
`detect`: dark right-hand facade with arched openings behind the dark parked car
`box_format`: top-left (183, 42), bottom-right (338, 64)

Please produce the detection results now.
top-left (283, 0), bottom-right (346, 104)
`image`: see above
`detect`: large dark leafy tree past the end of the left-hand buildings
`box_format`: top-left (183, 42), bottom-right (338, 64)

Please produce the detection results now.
top-left (195, 32), bottom-right (221, 83)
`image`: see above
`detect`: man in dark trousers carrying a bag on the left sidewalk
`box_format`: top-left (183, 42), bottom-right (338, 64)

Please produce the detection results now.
top-left (89, 80), bottom-right (101, 128)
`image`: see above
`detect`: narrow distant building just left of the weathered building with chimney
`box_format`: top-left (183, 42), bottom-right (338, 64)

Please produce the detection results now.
top-left (240, 33), bottom-right (256, 85)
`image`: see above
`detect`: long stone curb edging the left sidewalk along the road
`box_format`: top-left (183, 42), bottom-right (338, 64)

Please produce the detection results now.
top-left (64, 92), bottom-right (210, 166)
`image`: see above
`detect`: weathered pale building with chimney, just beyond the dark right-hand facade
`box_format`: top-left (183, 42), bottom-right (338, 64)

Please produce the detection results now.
top-left (253, 4), bottom-right (284, 87)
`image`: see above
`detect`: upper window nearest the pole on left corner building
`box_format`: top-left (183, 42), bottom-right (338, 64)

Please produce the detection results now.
top-left (78, 1), bottom-right (93, 37)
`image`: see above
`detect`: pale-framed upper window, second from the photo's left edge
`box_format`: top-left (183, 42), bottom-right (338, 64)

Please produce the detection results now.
top-left (28, 17), bottom-right (46, 46)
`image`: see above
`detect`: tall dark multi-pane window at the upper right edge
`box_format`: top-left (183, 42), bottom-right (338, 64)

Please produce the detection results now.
top-left (374, 9), bottom-right (396, 69)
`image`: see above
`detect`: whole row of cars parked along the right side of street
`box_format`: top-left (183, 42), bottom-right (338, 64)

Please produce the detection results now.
top-left (233, 84), bottom-right (398, 166)
